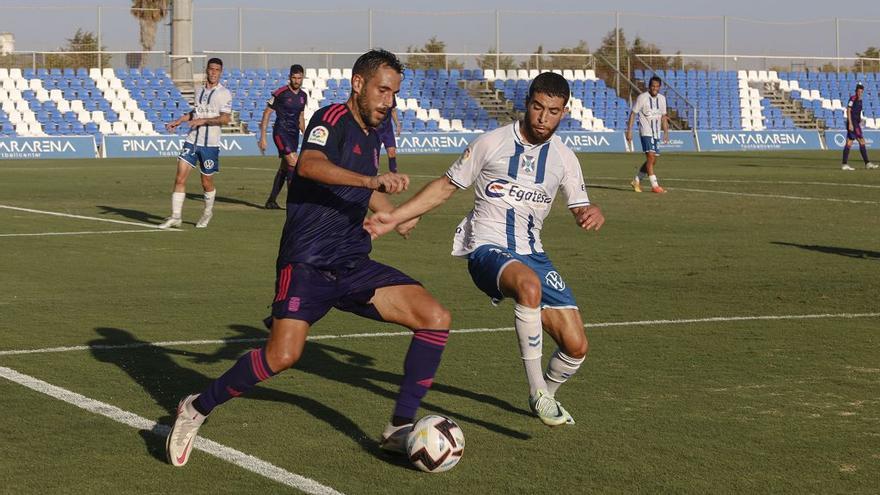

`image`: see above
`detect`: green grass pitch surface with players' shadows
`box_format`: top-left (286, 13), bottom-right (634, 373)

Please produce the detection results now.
top-left (0, 152), bottom-right (880, 494)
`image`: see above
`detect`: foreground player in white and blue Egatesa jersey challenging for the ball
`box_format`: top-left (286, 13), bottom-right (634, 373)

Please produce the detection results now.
top-left (365, 72), bottom-right (605, 426)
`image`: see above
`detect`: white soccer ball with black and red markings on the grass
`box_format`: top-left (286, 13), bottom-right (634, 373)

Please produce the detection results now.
top-left (406, 415), bottom-right (464, 473)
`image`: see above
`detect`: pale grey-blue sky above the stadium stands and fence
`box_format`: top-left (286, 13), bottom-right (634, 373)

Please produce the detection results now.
top-left (0, 0), bottom-right (880, 65)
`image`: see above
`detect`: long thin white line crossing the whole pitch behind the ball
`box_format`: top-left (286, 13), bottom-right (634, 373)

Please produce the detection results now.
top-left (0, 313), bottom-right (880, 356)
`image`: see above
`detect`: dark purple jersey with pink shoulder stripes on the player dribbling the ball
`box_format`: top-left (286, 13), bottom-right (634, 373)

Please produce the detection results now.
top-left (278, 104), bottom-right (379, 269)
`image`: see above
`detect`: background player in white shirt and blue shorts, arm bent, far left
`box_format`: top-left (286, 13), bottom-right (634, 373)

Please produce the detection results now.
top-left (159, 58), bottom-right (232, 229)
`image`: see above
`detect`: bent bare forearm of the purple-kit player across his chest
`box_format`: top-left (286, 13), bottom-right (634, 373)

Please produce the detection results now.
top-left (297, 150), bottom-right (409, 194)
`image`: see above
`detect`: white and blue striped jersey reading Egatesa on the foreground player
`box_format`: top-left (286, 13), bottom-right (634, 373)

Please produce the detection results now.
top-left (446, 122), bottom-right (590, 256)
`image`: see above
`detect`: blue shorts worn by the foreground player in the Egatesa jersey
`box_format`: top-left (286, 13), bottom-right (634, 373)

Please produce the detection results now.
top-left (468, 244), bottom-right (577, 309)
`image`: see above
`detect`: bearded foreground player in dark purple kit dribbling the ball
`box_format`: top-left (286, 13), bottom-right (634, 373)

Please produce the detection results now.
top-left (166, 50), bottom-right (450, 466)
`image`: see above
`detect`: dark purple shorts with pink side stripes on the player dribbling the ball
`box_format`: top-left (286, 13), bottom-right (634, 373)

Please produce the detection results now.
top-left (272, 258), bottom-right (421, 325)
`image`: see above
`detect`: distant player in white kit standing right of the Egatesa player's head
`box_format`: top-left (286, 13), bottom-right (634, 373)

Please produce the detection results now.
top-left (626, 76), bottom-right (669, 194)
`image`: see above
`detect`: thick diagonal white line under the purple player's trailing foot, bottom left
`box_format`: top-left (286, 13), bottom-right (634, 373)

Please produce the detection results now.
top-left (0, 366), bottom-right (342, 495)
